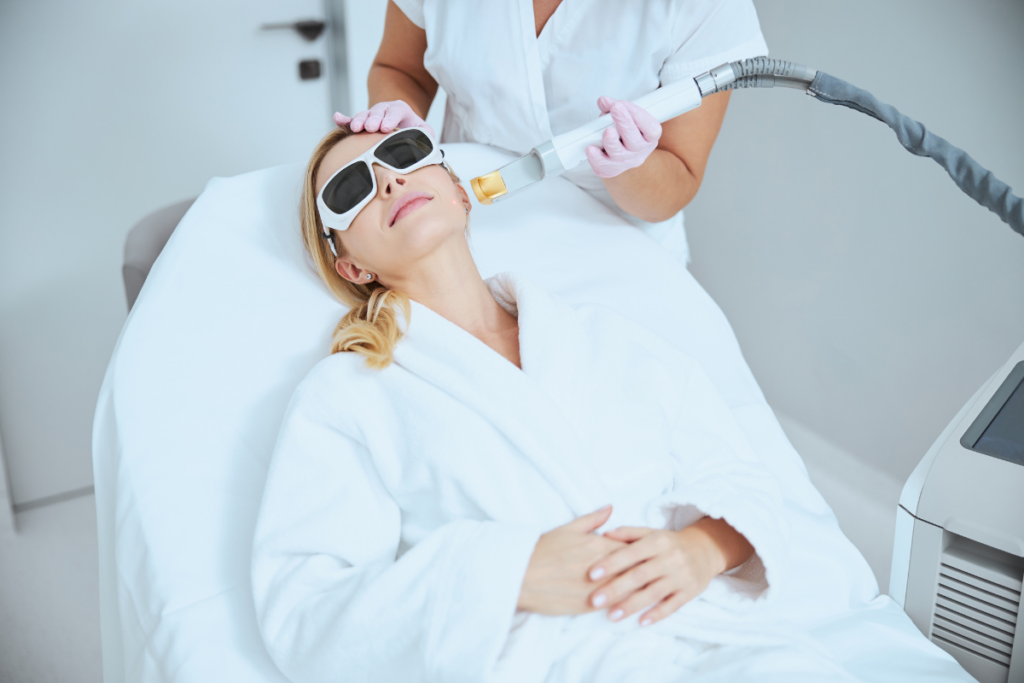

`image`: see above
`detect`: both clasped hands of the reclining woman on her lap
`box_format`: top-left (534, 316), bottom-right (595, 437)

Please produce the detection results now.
top-left (517, 505), bottom-right (724, 626)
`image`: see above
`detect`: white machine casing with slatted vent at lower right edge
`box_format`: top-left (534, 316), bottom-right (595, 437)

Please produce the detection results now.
top-left (889, 344), bottom-right (1024, 683)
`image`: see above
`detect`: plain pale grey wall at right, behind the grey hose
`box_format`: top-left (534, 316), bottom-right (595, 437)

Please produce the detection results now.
top-left (686, 0), bottom-right (1024, 481)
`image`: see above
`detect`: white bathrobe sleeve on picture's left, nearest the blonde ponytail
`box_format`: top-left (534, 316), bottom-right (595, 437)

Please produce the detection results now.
top-left (252, 358), bottom-right (541, 683)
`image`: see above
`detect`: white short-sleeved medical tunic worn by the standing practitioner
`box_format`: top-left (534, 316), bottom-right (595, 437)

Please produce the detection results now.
top-left (395, 0), bottom-right (768, 264)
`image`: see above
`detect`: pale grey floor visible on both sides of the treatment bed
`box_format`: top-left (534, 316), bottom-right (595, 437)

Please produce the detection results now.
top-left (0, 416), bottom-right (900, 683)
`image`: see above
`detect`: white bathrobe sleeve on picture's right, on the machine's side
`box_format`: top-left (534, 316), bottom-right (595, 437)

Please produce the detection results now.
top-left (614, 315), bottom-right (790, 610)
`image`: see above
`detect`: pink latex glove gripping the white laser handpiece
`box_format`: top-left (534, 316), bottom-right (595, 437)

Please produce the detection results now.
top-left (587, 97), bottom-right (662, 178)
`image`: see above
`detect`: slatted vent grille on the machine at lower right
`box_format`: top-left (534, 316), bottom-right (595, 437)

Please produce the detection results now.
top-left (932, 539), bottom-right (1022, 668)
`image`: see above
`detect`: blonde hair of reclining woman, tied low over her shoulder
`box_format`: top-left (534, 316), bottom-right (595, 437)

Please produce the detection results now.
top-left (299, 126), bottom-right (469, 370)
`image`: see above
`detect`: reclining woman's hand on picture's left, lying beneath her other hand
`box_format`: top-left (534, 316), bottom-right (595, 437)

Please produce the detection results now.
top-left (516, 505), bottom-right (627, 615)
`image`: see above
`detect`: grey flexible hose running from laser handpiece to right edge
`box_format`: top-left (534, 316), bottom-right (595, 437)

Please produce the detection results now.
top-left (696, 57), bottom-right (1024, 240)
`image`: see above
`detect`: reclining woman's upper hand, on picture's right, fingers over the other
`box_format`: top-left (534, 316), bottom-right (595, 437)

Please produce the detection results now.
top-left (589, 525), bottom-right (725, 626)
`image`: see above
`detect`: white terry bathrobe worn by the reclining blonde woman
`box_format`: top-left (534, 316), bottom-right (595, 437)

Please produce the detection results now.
top-left (253, 273), bottom-right (851, 683)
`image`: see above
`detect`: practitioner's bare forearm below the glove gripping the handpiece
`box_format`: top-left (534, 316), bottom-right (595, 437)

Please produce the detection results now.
top-left (602, 150), bottom-right (700, 223)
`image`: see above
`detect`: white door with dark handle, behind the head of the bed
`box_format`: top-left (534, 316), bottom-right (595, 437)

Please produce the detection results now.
top-left (0, 0), bottom-right (332, 504)
